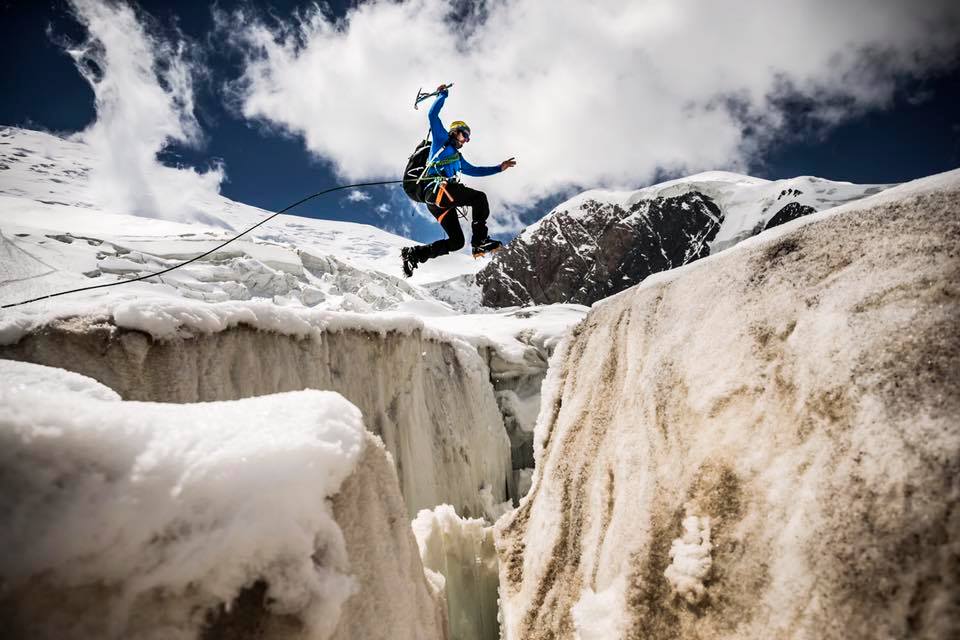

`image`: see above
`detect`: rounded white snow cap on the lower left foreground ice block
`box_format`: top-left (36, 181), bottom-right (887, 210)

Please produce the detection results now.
top-left (0, 361), bottom-right (365, 638)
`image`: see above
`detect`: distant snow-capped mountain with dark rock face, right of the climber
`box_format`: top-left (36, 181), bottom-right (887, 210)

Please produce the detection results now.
top-left (476, 171), bottom-right (887, 307)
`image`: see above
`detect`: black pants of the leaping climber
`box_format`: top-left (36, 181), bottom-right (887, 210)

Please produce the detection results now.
top-left (417, 182), bottom-right (490, 262)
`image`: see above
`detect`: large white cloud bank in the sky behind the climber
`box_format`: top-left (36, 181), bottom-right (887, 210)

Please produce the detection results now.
top-left (228, 0), bottom-right (960, 228)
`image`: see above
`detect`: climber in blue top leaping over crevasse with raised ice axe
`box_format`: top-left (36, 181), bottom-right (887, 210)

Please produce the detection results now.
top-left (400, 85), bottom-right (517, 278)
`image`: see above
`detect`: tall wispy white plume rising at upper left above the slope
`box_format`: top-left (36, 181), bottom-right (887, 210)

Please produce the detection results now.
top-left (68, 0), bottom-right (228, 226)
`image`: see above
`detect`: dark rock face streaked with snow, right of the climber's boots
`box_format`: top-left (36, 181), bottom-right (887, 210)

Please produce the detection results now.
top-left (477, 191), bottom-right (723, 307)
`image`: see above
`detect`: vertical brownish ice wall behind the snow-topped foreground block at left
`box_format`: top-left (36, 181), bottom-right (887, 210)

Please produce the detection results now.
top-left (0, 318), bottom-right (510, 519)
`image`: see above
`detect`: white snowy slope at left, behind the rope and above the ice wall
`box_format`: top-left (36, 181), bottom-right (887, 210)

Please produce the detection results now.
top-left (0, 128), bottom-right (588, 351)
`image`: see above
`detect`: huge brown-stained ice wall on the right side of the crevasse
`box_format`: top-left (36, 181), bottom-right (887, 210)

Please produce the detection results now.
top-left (496, 182), bottom-right (960, 640)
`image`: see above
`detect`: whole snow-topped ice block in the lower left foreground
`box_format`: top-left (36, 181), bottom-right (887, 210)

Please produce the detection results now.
top-left (0, 361), bottom-right (446, 640)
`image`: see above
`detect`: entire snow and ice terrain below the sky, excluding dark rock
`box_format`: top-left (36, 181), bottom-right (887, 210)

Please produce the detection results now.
top-left (0, 121), bottom-right (960, 640)
